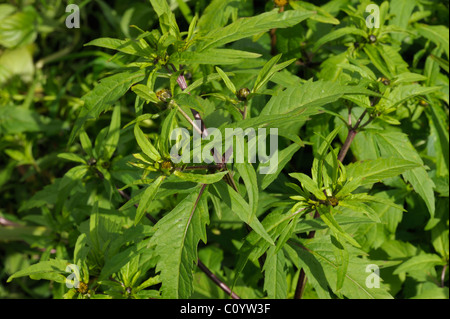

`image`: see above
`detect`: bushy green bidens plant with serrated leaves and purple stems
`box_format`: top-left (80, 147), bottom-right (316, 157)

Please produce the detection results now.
top-left (0, 0), bottom-right (449, 299)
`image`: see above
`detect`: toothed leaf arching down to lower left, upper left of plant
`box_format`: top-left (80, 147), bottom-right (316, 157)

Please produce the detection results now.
top-left (68, 70), bottom-right (145, 145)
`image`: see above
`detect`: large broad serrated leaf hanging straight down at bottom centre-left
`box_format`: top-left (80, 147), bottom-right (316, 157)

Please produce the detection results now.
top-left (150, 186), bottom-right (209, 298)
